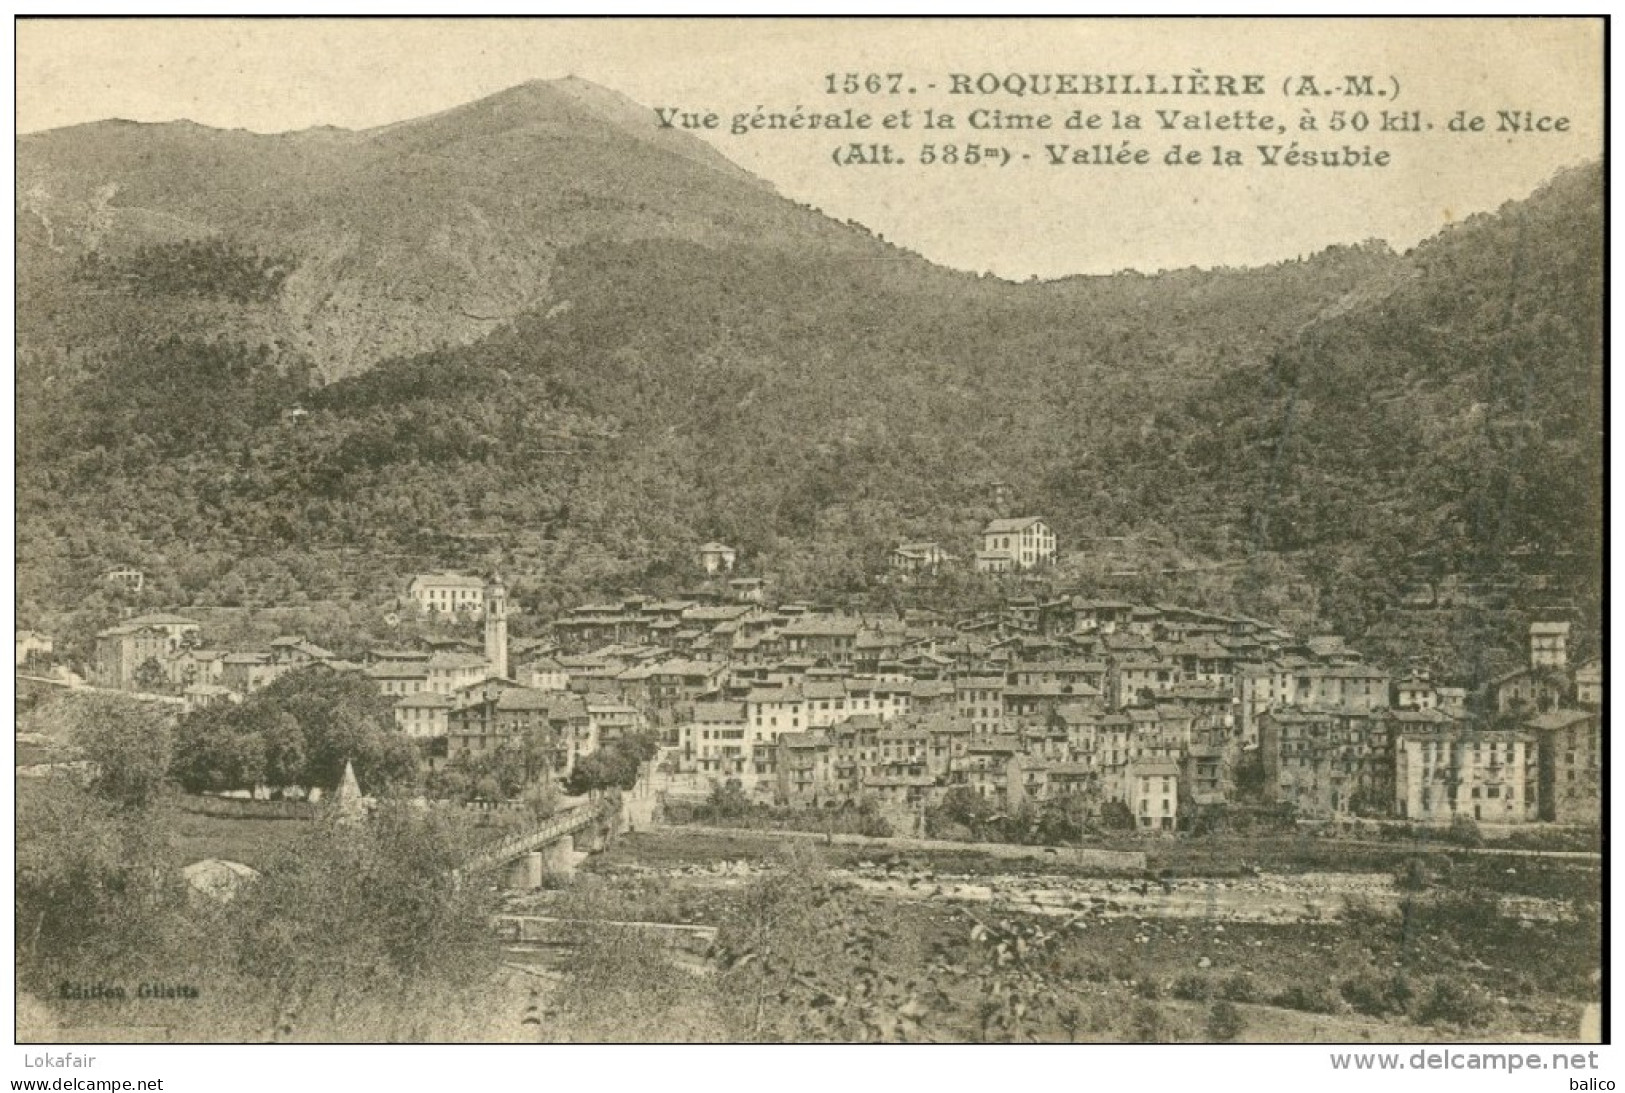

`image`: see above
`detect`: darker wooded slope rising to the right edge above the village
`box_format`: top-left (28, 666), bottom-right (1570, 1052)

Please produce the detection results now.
top-left (1092, 166), bottom-right (1606, 672)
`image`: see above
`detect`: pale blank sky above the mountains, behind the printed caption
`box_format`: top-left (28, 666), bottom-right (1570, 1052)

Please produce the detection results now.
top-left (16, 19), bottom-right (1602, 278)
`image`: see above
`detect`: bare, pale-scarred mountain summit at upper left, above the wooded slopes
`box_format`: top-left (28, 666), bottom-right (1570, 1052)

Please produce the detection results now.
top-left (18, 81), bottom-right (923, 378)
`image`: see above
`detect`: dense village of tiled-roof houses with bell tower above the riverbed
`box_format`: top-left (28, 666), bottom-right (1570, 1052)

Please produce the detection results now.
top-left (38, 518), bottom-right (1602, 832)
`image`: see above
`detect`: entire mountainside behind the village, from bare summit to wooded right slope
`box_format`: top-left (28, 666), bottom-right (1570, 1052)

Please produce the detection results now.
top-left (18, 84), bottom-right (1602, 682)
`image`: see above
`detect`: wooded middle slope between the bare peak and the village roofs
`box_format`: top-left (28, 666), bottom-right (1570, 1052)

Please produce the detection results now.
top-left (20, 242), bottom-right (1394, 626)
